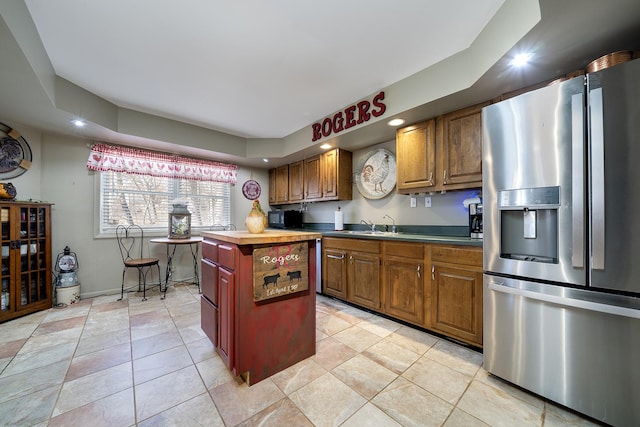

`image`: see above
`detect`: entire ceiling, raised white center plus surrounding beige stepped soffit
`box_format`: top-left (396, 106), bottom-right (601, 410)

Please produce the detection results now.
top-left (0, 0), bottom-right (640, 167)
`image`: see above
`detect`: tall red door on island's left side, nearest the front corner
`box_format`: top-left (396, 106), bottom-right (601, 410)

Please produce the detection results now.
top-left (216, 267), bottom-right (235, 370)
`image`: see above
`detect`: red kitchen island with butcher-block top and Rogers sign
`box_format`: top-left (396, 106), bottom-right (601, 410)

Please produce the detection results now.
top-left (201, 230), bottom-right (321, 385)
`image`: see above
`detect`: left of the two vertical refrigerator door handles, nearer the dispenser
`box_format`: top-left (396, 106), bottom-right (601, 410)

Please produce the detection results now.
top-left (571, 93), bottom-right (584, 268)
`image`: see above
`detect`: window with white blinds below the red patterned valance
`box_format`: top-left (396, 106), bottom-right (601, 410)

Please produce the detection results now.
top-left (100, 171), bottom-right (231, 233)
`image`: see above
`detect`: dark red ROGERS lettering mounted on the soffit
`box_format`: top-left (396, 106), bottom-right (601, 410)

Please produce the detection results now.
top-left (311, 91), bottom-right (387, 141)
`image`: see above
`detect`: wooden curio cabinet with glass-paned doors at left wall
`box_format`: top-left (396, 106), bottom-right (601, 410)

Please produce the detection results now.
top-left (0, 202), bottom-right (52, 322)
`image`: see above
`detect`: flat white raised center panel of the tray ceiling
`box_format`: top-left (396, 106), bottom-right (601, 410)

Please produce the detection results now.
top-left (26, 0), bottom-right (504, 138)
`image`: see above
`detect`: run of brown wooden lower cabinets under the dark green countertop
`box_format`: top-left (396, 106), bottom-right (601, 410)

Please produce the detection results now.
top-left (322, 237), bottom-right (482, 347)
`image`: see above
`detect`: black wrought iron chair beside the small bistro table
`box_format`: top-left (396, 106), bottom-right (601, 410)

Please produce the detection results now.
top-left (116, 225), bottom-right (167, 301)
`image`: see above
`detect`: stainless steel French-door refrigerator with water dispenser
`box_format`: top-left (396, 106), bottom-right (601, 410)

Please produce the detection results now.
top-left (482, 60), bottom-right (640, 426)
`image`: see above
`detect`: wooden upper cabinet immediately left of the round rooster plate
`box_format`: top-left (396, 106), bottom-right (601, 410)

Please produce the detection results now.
top-left (321, 148), bottom-right (352, 200)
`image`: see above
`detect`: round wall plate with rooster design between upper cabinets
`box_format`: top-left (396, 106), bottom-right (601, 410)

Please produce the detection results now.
top-left (355, 148), bottom-right (396, 199)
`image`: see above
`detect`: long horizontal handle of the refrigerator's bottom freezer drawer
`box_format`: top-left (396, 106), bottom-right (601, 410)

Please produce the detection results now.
top-left (487, 282), bottom-right (640, 319)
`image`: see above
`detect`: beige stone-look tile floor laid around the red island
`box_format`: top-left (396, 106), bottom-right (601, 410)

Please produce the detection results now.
top-left (0, 285), bottom-right (593, 427)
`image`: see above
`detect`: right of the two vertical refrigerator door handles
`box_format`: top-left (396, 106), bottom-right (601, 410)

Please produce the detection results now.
top-left (589, 88), bottom-right (605, 270)
